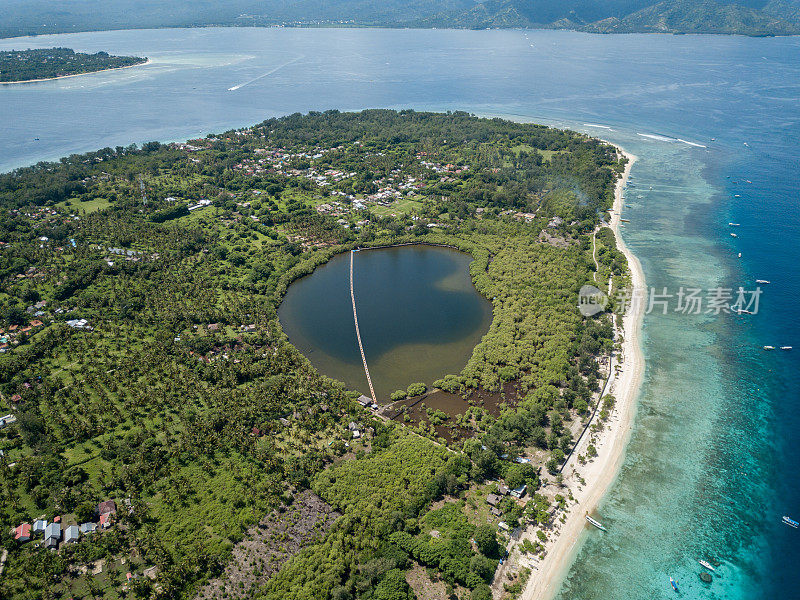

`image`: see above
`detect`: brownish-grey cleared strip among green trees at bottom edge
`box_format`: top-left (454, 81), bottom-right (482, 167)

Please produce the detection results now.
top-left (197, 491), bottom-right (341, 600)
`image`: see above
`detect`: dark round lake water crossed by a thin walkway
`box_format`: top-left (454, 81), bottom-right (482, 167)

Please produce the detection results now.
top-left (278, 246), bottom-right (492, 401)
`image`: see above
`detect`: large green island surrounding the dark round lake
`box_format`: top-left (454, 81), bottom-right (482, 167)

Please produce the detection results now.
top-left (0, 110), bottom-right (641, 600)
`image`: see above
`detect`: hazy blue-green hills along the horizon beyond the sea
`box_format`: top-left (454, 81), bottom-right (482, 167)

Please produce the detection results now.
top-left (0, 0), bottom-right (800, 37)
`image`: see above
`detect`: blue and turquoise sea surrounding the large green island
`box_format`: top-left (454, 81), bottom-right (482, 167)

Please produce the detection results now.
top-left (0, 29), bottom-right (800, 600)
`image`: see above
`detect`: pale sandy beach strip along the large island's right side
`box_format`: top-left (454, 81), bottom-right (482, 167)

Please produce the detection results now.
top-left (512, 144), bottom-right (645, 600)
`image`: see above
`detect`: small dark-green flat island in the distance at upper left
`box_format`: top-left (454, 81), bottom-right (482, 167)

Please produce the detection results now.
top-left (0, 48), bottom-right (147, 83)
